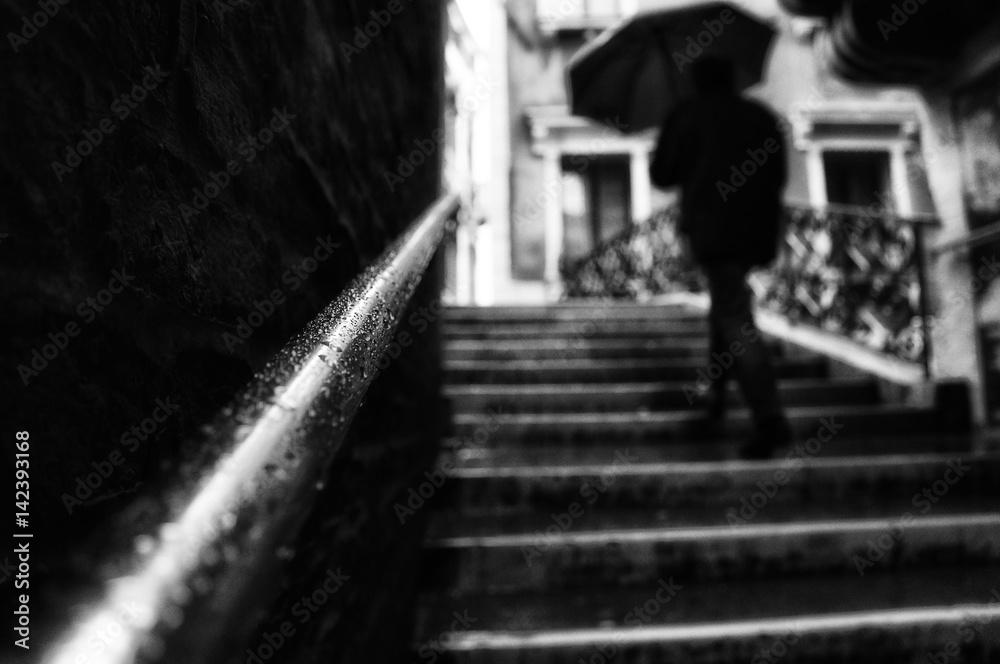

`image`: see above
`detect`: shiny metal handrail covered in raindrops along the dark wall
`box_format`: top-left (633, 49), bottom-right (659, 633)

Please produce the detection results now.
top-left (44, 195), bottom-right (459, 664)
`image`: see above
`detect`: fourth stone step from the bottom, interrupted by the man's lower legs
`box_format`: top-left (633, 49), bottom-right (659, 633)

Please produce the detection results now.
top-left (453, 405), bottom-right (946, 450)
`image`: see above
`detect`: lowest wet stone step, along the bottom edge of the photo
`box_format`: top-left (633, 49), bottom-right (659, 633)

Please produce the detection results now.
top-left (414, 567), bottom-right (1000, 664)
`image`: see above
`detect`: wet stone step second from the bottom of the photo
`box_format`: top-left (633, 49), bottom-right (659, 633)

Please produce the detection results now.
top-left (423, 508), bottom-right (1000, 594)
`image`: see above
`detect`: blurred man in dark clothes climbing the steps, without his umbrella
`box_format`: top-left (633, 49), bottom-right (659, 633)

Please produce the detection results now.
top-left (650, 56), bottom-right (791, 458)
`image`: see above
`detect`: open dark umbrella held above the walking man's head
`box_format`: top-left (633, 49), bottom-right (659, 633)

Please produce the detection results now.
top-left (567, 2), bottom-right (776, 133)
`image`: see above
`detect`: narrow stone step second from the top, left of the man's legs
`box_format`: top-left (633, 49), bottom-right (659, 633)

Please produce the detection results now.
top-left (444, 317), bottom-right (708, 342)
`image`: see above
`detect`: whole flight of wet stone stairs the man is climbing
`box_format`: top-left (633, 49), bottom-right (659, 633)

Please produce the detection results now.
top-left (411, 304), bottom-right (1000, 664)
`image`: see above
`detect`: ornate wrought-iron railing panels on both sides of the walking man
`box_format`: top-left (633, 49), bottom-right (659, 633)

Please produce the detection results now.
top-left (562, 205), bottom-right (934, 368)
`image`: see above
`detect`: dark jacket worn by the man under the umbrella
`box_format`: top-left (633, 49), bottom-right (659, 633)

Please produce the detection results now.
top-left (650, 94), bottom-right (787, 266)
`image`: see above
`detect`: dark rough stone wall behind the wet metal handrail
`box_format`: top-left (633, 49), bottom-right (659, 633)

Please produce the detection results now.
top-left (0, 0), bottom-right (444, 661)
